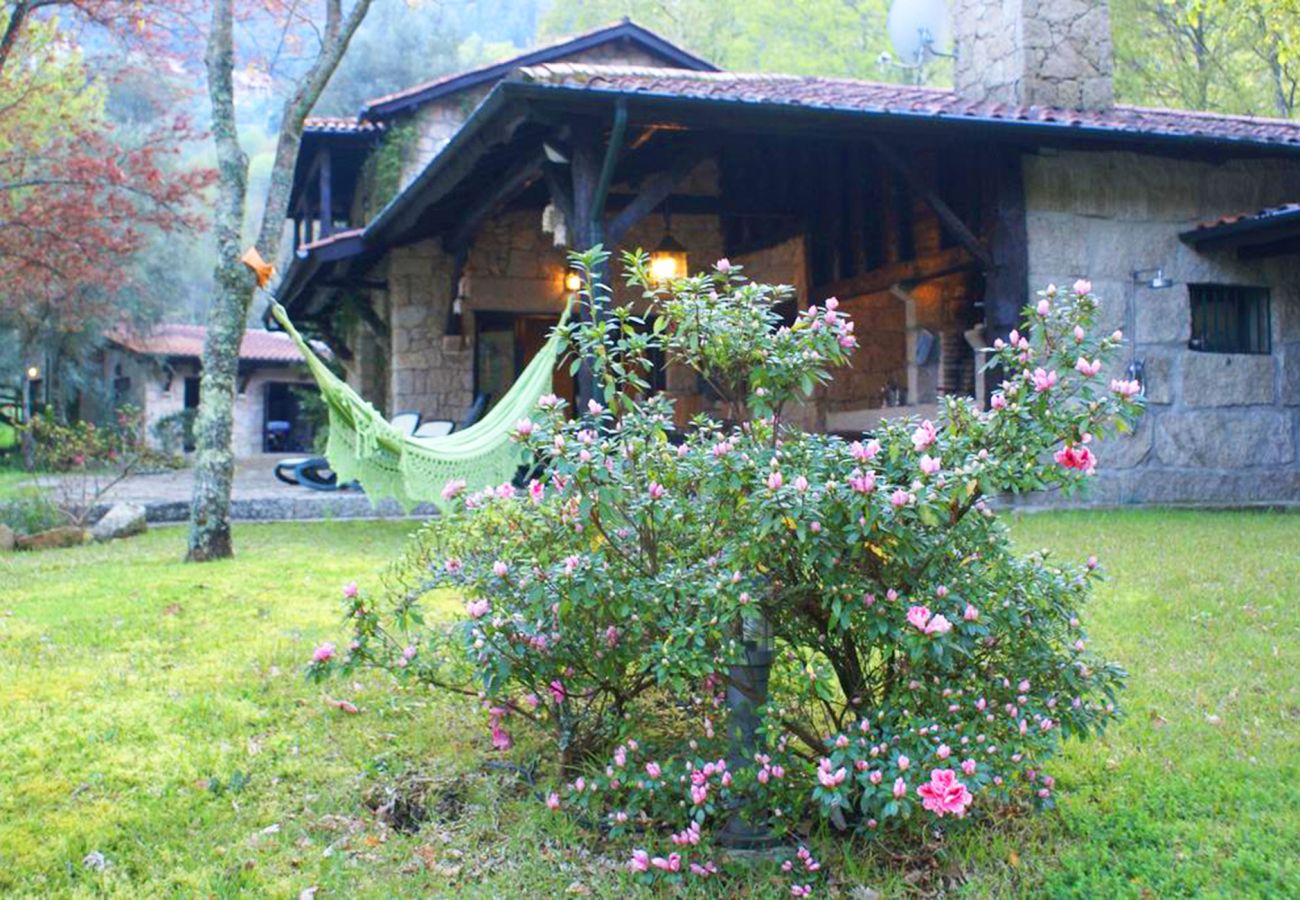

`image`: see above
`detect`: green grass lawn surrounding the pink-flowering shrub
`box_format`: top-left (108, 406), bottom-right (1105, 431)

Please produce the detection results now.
top-left (0, 511), bottom-right (1300, 897)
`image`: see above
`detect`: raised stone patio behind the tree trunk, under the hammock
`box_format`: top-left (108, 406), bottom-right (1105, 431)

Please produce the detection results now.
top-left (29, 454), bottom-right (437, 524)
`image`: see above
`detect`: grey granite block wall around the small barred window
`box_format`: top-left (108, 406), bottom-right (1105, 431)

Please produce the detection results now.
top-left (1024, 144), bottom-right (1300, 503)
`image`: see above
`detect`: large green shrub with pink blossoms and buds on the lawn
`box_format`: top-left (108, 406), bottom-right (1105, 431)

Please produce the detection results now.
top-left (312, 249), bottom-right (1139, 895)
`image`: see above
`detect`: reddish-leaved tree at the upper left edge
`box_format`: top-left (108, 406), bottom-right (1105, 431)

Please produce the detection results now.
top-left (0, 3), bottom-right (211, 447)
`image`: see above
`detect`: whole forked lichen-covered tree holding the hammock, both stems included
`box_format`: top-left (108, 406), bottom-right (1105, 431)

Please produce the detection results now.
top-left (187, 0), bottom-right (371, 562)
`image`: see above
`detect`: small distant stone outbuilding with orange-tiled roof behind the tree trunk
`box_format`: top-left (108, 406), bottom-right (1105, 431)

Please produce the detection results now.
top-left (99, 325), bottom-right (325, 458)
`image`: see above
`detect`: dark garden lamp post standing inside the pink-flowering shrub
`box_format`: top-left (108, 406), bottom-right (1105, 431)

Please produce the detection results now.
top-left (719, 613), bottom-right (780, 851)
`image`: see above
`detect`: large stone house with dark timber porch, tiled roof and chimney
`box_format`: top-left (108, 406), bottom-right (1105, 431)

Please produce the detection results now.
top-left (280, 10), bottom-right (1300, 503)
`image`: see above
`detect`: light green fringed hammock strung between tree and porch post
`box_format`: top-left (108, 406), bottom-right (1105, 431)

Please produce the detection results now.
top-left (270, 302), bottom-right (568, 510)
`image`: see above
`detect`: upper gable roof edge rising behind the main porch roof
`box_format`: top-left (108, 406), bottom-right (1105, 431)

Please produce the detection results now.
top-left (361, 20), bottom-right (716, 117)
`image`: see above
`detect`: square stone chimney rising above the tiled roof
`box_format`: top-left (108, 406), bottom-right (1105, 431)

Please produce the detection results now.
top-left (953, 0), bottom-right (1115, 109)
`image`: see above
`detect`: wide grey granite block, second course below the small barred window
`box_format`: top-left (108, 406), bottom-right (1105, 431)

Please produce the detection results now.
top-left (1156, 408), bottom-right (1295, 468)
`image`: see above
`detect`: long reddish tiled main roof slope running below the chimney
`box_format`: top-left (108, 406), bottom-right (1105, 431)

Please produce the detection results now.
top-left (517, 62), bottom-right (1300, 147)
